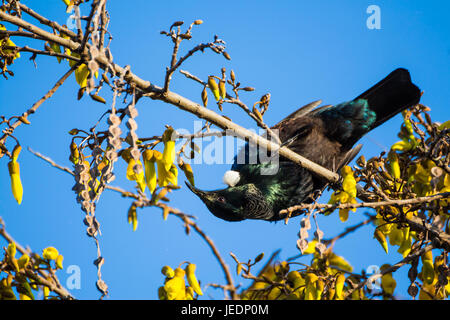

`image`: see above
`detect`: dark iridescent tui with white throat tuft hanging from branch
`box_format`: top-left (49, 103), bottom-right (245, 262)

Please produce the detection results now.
top-left (186, 68), bottom-right (421, 221)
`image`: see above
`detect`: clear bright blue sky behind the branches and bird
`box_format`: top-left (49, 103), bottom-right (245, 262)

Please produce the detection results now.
top-left (0, 0), bottom-right (450, 299)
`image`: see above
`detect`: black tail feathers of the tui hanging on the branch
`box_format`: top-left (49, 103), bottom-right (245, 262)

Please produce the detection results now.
top-left (355, 68), bottom-right (421, 129)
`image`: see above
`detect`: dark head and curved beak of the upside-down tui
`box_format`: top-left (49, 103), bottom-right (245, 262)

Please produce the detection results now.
top-left (186, 182), bottom-right (246, 221)
